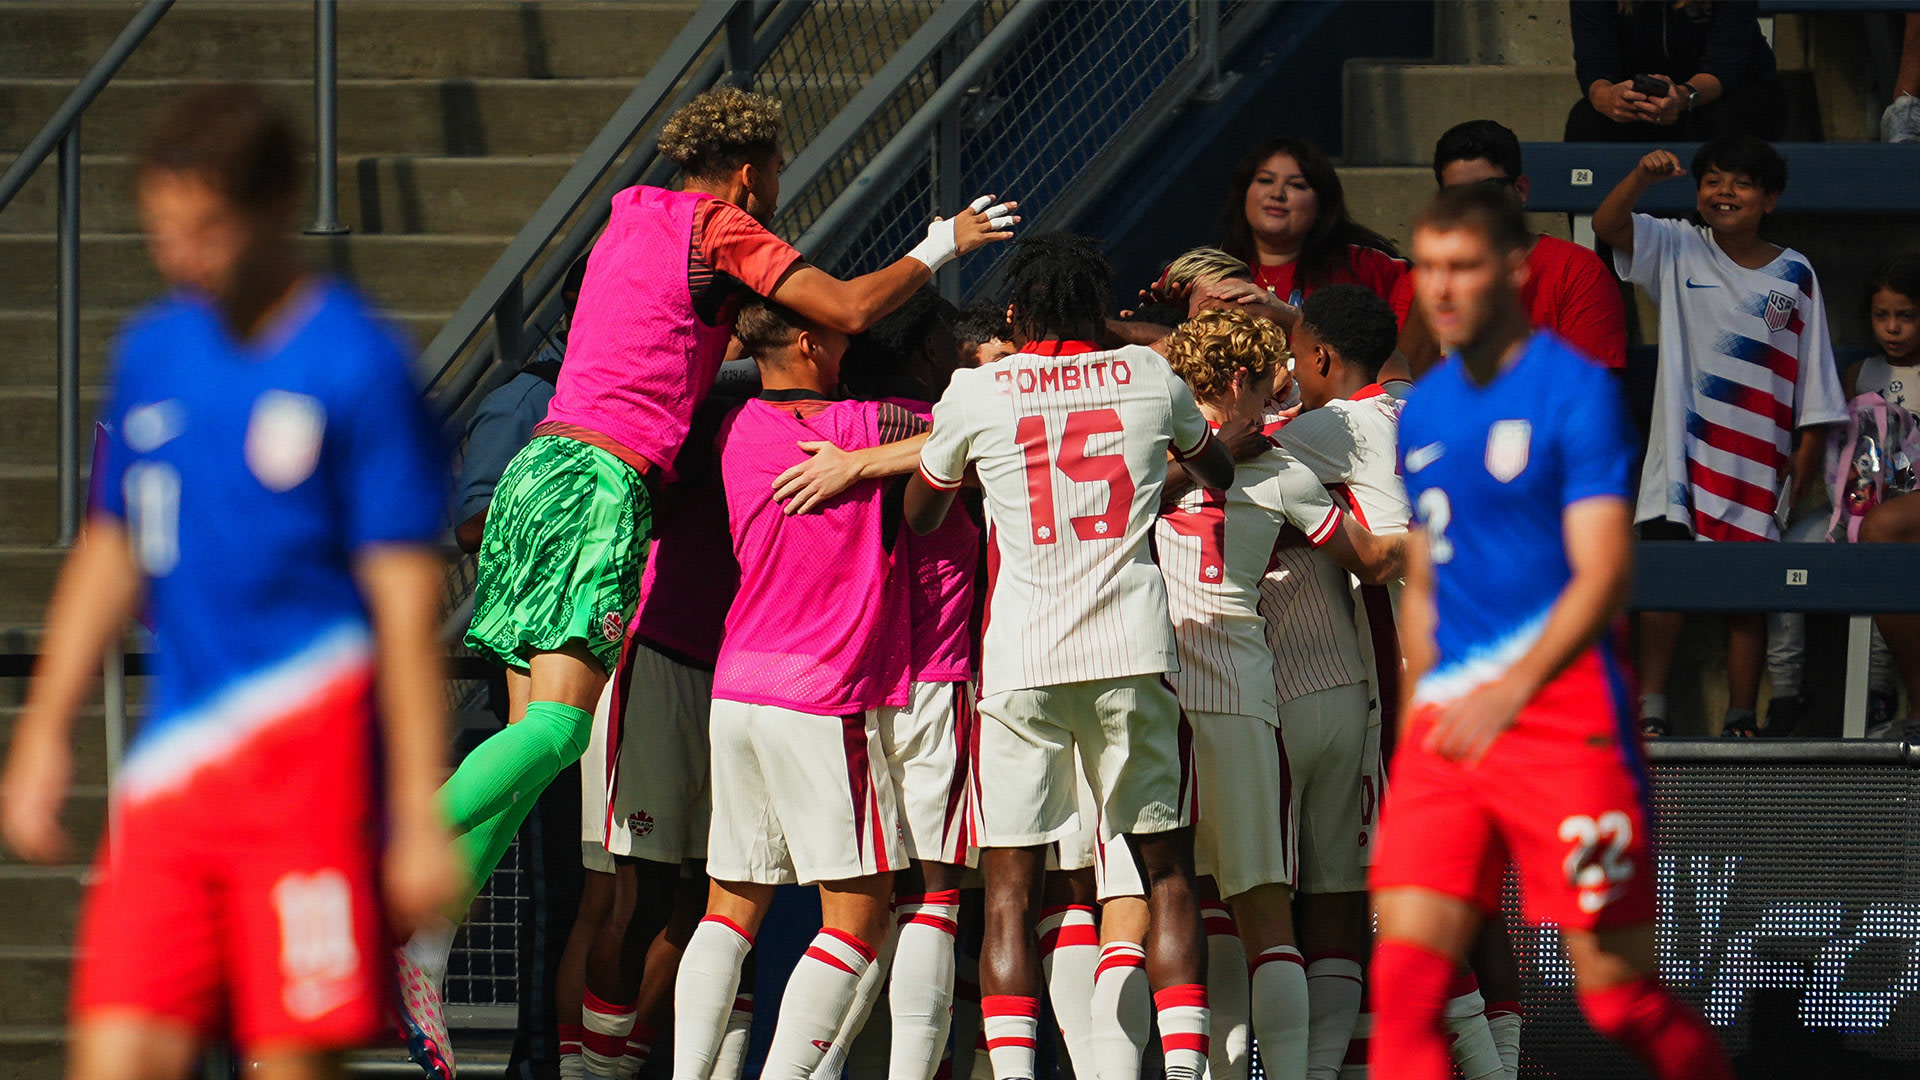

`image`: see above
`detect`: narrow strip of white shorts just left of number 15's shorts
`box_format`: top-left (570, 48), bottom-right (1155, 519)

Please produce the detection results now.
top-left (877, 682), bottom-right (975, 865)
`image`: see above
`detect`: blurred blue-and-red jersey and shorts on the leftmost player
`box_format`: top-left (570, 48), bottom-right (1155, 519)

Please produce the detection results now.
top-left (77, 281), bottom-right (447, 1045)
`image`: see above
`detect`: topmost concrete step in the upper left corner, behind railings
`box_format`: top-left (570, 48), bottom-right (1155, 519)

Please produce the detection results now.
top-left (0, 0), bottom-right (697, 79)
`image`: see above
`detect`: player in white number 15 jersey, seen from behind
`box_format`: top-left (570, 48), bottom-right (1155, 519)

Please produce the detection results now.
top-left (906, 234), bottom-right (1233, 1080)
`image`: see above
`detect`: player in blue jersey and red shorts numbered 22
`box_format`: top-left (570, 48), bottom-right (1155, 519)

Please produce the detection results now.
top-left (1373, 186), bottom-right (1732, 1080)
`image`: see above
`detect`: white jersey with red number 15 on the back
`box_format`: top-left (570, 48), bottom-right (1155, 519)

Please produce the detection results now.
top-left (920, 342), bottom-right (1208, 696)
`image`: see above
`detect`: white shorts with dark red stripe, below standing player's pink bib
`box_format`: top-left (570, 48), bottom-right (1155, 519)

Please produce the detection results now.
top-left (707, 698), bottom-right (906, 884)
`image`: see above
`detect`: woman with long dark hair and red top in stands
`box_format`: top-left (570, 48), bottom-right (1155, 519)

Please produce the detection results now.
top-left (1217, 135), bottom-right (1413, 319)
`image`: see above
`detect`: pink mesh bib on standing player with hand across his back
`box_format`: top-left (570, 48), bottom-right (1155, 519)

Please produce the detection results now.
top-left (714, 400), bottom-right (908, 717)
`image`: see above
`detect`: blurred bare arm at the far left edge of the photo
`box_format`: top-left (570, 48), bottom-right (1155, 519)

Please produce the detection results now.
top-left (0, 515), bottom-right (142, 863)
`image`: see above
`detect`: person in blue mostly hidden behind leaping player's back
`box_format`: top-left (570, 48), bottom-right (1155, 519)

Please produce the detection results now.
top-left (453, 256), bottom-right (588, 555)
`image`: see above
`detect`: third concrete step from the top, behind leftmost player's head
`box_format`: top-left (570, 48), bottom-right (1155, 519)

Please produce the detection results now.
top-left (0, 154), bottom-right (574, 234)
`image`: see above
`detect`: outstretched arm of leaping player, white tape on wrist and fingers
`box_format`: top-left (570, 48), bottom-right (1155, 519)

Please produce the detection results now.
top-left (770, 196), bottom-right (1020, 334)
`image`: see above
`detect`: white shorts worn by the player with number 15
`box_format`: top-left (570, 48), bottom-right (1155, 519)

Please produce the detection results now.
top-left (973, 675), bottom-right (1196, 847)
